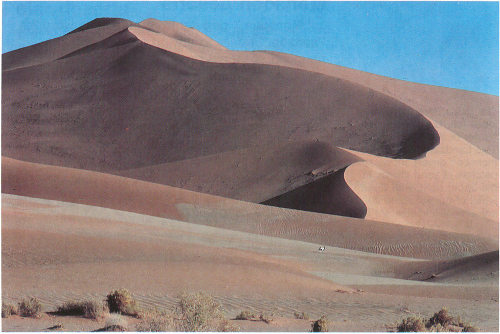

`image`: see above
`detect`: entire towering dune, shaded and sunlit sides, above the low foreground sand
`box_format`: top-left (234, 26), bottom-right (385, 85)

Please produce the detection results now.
top-left (2, 18), bottom-right (498, 235)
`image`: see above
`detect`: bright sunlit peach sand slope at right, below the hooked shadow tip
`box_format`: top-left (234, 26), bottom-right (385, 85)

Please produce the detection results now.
top-left (346, 124), bottom-right (498, 237)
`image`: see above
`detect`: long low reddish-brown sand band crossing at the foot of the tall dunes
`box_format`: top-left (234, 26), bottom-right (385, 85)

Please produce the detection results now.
top-left (2, 157), bottom-right (498, 259)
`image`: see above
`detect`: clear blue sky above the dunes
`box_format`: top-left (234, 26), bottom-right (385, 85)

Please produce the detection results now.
top-left (2, 1), bottom-right (499, 95)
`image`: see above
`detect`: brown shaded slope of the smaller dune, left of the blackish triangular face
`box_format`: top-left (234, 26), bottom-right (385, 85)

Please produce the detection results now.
top-left (118, 141), bottom-right (360, 205)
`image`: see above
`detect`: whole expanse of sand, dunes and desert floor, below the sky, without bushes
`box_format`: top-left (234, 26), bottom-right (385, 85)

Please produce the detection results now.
top-left (1, 19), bottom-right (499, 332)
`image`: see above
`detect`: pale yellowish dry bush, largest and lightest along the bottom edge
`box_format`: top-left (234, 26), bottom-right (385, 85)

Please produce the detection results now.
top-left (176, 292), bottom-right (229, 332)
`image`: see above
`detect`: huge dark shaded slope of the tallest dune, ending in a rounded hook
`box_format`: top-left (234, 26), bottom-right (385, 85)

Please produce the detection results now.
top-left (2, 26), bottom-right (439, 175)
